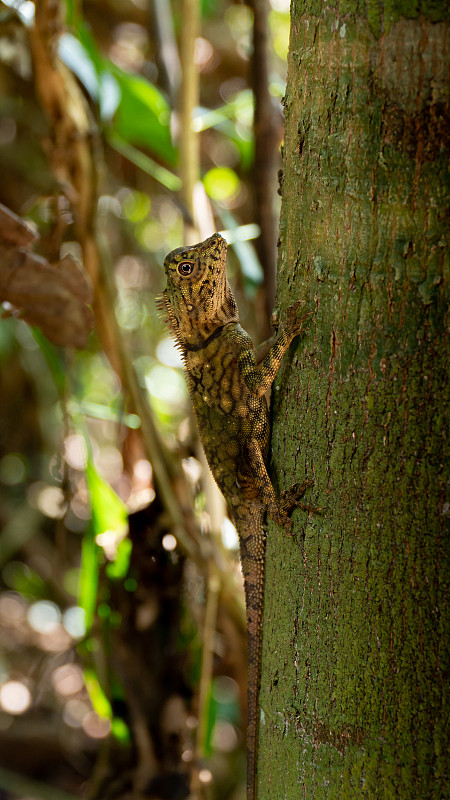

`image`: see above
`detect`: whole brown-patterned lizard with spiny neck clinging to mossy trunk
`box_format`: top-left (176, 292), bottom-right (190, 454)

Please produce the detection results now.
top-left (158, 233), bottom-right (320, 800)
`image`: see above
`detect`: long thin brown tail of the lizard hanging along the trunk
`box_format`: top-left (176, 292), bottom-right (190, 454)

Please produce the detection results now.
top-left (233, 503), bottom-right (265, 800)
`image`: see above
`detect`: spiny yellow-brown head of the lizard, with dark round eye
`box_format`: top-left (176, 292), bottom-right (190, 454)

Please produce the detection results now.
top-left (160, 233), bottom-right (239, 343)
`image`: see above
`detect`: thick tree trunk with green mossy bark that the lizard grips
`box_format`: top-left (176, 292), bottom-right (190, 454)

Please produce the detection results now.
top-left (258, 0), bottom-right (450, 800)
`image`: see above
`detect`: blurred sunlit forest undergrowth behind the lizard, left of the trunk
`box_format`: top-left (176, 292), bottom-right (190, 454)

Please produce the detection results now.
top-left (0, 0), bottom-right (289, 799)
